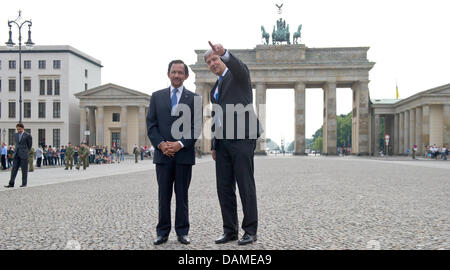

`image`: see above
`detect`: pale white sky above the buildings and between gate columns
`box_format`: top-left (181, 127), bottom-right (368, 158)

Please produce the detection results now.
top-left (0, 0), bottom-right (450, 146)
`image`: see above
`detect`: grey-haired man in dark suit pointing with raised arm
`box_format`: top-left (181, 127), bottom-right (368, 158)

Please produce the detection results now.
top-left (204, 42), bottom-right (262, 245)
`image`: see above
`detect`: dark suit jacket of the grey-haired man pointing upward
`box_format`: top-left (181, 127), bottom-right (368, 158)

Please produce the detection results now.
top-left (210, 53), bottom-right (263, 149)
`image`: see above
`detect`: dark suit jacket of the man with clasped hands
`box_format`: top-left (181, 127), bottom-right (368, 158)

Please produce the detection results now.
top-left (146, 87), bottom-right (202, 165)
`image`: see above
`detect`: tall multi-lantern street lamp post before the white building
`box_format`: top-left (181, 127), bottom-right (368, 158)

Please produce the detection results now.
top-left (5, 10), bottom-right (34, 123)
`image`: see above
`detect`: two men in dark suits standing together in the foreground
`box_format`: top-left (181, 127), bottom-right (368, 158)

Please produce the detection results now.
top-left (146, 42), bottom-right (262, 245)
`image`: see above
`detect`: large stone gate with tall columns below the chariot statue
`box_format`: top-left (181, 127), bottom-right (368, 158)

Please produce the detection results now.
top-left (190, 44), bottom-right (375, 155)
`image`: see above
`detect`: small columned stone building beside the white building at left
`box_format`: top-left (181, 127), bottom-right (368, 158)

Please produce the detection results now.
top-left (75, 84), bottom-right (150, 153)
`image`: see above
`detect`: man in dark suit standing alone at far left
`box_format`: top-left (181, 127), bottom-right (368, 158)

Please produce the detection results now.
top-left (5, 123), bottom-right (33, 188)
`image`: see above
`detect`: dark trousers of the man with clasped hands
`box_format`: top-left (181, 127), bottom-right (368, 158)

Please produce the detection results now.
top-left (156, 161), bottom-right (192, 236)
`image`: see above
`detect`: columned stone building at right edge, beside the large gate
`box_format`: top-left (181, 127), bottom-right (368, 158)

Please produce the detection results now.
top-left (370, 84), bottom-right (450, 155)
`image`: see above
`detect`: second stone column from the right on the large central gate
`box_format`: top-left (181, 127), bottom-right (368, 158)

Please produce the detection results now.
top-left (322, 82), bottom-right (337, 155)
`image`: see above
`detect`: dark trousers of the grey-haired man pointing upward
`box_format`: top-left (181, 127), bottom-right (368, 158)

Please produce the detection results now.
top-left (216, 140), bottom-right (258, 235)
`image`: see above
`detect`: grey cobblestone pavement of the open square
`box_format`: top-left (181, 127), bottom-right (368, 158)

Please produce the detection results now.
top-left (0, 156), bottom-right (450, 249)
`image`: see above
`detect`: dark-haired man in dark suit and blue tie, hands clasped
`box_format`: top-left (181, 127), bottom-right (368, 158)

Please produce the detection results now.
top-left (147, 60), bottom-right (202, 245)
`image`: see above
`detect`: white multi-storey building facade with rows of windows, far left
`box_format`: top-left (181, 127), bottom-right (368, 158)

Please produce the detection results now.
top-left (0, 46), bottom-right (102, 148)
